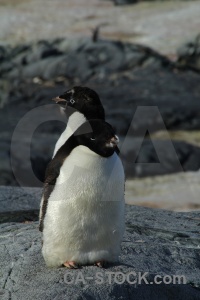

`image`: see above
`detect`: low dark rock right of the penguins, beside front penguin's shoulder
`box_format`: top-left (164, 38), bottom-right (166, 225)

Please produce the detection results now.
top-left (119, 138), bottom-right (200, 178)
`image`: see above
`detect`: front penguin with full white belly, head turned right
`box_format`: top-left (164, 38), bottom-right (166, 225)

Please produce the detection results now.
top-left (40, 120), bottom-right (125, 268)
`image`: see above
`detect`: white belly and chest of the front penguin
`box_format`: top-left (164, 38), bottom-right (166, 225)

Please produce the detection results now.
top-left (43, 146), bottom-right (124, 266)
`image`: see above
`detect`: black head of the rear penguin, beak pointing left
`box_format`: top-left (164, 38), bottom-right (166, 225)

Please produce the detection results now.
top-left (53, 86), bottom-right (105, 120)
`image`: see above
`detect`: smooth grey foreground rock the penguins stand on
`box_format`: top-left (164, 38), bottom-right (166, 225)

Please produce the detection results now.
top-left (0, 189), bottom-right (200, 300)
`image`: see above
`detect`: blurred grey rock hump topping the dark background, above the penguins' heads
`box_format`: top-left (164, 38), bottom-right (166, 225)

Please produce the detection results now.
top-left (0, 38), bottom-right (170, 80)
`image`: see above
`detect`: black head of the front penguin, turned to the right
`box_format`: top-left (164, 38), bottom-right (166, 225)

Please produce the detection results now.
top-left (74, 120), bottom-right (119, 157)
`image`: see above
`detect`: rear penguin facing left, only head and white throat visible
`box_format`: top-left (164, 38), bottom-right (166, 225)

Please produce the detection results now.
top-left (52, 86), bottom-right (105, 157)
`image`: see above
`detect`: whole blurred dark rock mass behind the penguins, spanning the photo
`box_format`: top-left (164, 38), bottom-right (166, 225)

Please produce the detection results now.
top-left (0, 38), bottom-right (200, 186)
